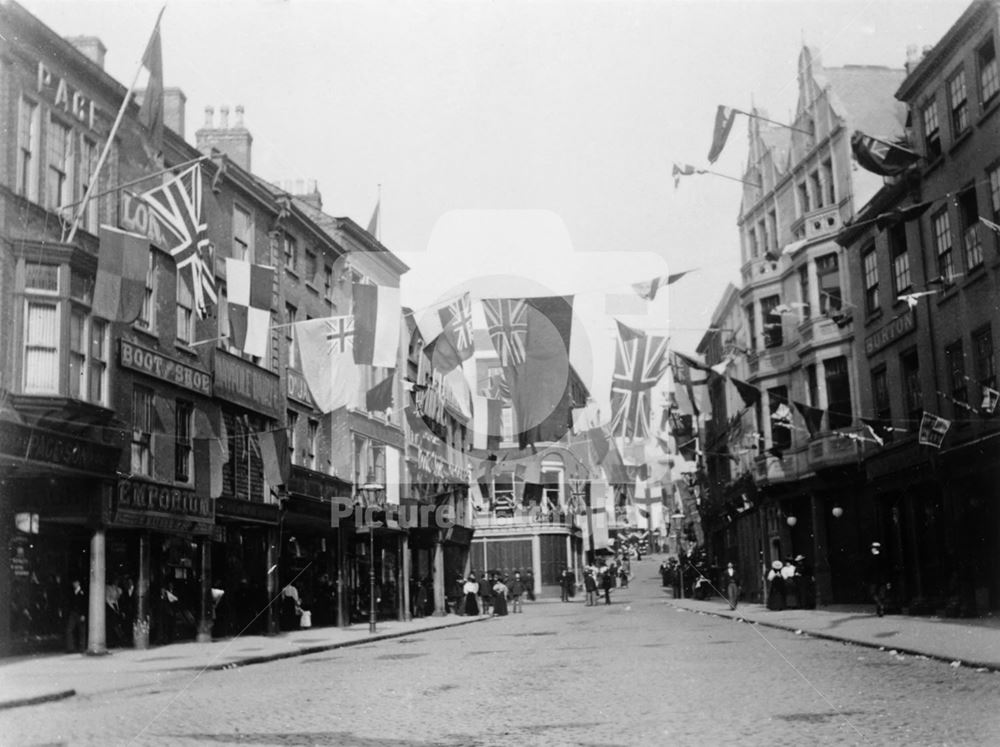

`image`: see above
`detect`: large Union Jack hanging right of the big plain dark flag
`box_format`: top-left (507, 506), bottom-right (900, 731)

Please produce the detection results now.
top-left (611, 322), bottom-right (668, 438)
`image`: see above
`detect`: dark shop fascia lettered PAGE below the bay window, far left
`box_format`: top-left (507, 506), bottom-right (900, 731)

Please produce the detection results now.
top-left (0, 420), bottom-right (121, 474)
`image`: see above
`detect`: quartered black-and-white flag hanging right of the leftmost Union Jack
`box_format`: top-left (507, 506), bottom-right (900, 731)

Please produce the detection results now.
top-left (226, 257), bottom-right (274, 358)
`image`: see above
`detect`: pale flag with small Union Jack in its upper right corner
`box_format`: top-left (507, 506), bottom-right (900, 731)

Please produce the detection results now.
top-left (294, 316), bottom-right (361, 413)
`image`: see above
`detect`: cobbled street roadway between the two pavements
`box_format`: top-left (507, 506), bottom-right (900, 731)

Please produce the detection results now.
top-left (0, 561), bottom-right (1000, 746)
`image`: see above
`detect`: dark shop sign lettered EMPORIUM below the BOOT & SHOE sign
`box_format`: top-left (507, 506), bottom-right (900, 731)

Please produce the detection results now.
top-left (113, 478), bottom-right (215, 534)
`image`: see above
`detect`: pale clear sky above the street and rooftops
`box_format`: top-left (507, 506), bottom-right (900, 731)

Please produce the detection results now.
top-left (21, 0), bottom-right (968, 360)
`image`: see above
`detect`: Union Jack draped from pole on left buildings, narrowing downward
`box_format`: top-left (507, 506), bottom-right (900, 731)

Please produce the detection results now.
top-left (139, 163), bottom-right (218, 319)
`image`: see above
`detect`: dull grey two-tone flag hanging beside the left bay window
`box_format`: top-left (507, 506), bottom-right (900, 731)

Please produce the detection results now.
top-left (92, 226), bottom-right (149, 324)
